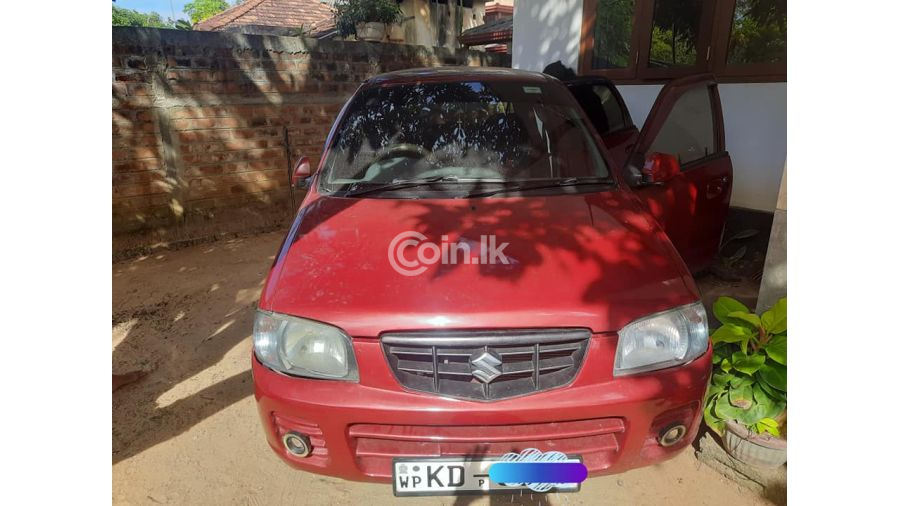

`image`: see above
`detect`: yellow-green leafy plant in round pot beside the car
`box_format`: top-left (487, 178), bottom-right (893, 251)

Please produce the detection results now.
top-left (703, 297), bottom-right (787, 467)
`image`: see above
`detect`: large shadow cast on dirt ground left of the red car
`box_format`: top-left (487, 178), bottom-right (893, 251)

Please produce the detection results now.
top-left (112, 233), bottom-right (282, 463)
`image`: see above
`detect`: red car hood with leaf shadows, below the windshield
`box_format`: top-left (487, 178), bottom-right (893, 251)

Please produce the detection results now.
top-left (260, 190), bottom-right (699, 337)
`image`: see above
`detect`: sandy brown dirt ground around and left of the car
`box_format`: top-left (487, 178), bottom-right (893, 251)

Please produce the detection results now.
top-left (112, 232), bottom-right (768, 506)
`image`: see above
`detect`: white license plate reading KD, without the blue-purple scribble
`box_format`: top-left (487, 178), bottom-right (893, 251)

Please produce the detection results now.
top-left (393, 457), bottom-right (581, 497)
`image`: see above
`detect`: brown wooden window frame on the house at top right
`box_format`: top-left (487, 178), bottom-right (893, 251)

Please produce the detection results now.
top-left (578, 0), bottom-right (787, 84)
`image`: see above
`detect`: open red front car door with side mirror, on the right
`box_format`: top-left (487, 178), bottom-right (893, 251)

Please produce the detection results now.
top-left (625, 74), bottom-right (732, 272)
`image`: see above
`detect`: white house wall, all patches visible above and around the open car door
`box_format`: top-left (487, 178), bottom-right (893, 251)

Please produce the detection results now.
top-left (512, 0), bottom-right (787, 212)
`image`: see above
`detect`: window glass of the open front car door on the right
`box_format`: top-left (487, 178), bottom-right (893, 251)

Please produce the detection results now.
top-left (650, 86), bottom-right (716, 164)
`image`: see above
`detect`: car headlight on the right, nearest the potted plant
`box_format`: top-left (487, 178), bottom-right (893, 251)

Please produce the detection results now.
top-left (613, 302), bottom-right (709, 376)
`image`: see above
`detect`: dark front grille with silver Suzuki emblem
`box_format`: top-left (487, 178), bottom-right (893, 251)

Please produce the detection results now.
top-left (381, 329), bottom-right (591, 401)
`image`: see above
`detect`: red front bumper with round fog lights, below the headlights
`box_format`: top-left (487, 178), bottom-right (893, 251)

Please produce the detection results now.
top-left (252, 335), bottom-right (712, 482)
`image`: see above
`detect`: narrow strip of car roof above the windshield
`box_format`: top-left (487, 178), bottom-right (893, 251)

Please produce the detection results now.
top-left (365, 66), bottom-right (557, 86)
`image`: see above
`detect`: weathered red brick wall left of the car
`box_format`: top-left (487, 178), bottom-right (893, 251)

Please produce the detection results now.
top-left (112, 27), bottom-right (509, 245)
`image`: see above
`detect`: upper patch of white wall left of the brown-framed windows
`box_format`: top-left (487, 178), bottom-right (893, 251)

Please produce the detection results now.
top-left (512, 0), bottom-right (582, 71)
